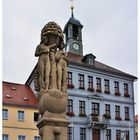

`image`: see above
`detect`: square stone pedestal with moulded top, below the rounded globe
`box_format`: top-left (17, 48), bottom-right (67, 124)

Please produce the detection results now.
top-left (37, 118), bottom-right (69, 140)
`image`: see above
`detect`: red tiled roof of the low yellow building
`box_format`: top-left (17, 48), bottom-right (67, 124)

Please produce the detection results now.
top-left (2, 82), bottom-right (37, 108)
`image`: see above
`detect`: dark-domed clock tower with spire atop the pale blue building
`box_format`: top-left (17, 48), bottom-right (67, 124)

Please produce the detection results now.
top-left (64, 6), bottom-right (83, 55)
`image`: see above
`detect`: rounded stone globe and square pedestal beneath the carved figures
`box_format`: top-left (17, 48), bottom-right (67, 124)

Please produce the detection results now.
top-left (37, 90), bottom-right (69, 140)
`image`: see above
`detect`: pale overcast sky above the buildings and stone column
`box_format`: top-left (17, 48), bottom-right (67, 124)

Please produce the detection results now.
top-left (2, 0), bottom-right (138, 112)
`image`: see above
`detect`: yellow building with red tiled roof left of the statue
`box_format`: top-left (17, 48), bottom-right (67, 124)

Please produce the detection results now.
top-left (2, 82), bottom-right (40, 140)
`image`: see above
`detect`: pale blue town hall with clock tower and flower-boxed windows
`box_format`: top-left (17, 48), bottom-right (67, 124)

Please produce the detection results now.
top-left (26, 13), bottom-right (137, 140)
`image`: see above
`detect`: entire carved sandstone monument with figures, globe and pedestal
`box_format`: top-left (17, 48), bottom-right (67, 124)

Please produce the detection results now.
top-left (34, 22), bottom-right (69, 140)
